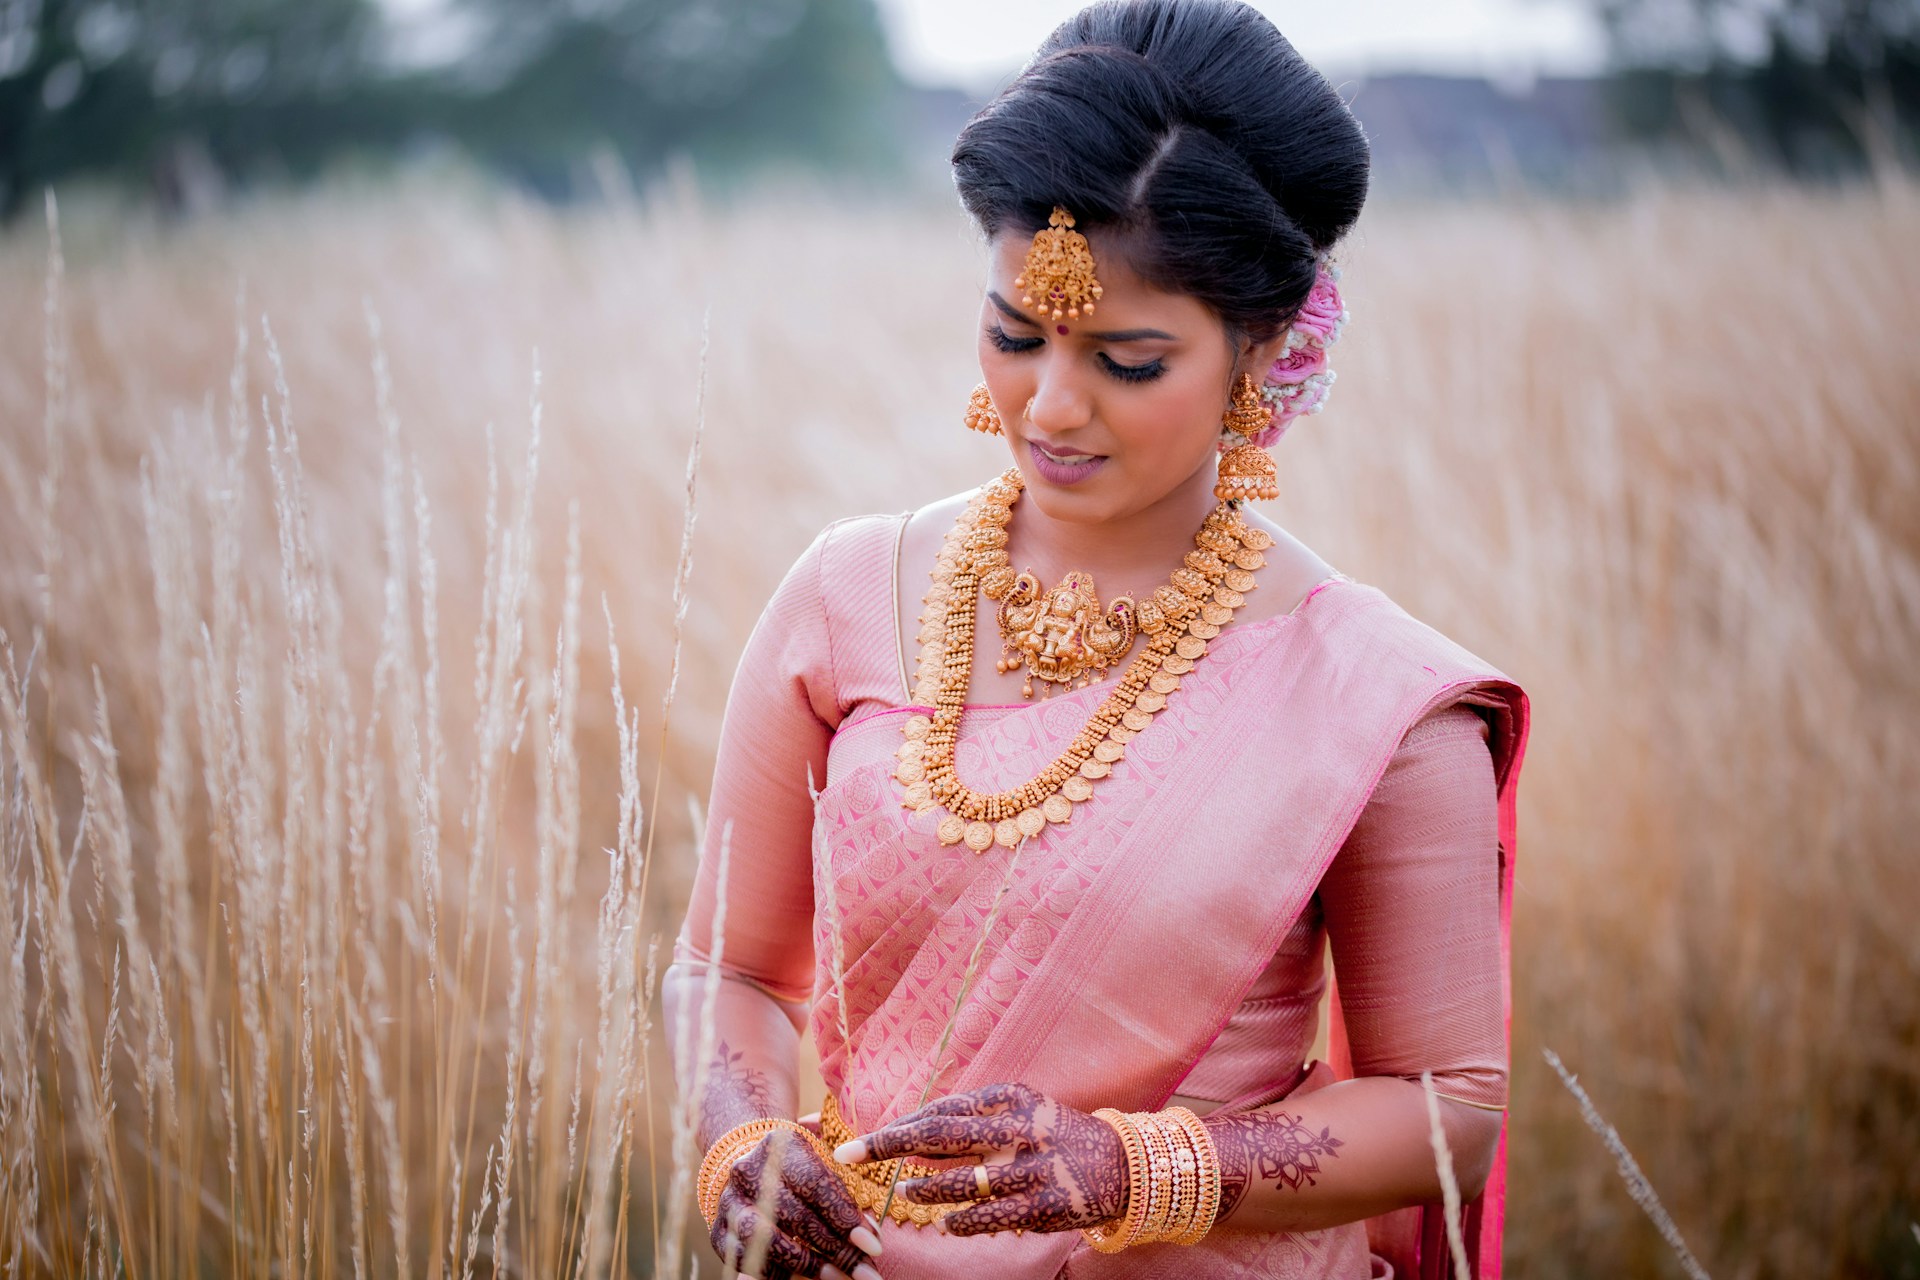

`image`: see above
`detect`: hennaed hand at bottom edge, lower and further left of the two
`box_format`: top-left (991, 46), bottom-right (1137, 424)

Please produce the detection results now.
top-left (712, 1130), bottom-right (881, 1280)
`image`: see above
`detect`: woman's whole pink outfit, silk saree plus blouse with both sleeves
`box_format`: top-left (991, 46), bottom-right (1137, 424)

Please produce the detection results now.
top-left (676, 516), bottom-right (1526, 1280)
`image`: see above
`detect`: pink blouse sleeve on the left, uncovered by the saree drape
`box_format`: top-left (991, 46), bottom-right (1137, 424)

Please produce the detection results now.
top-left (674, 526), bottom-right (841, 1002)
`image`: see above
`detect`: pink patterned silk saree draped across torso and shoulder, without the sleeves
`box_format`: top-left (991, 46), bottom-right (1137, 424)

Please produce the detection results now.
top-left (812, 578), bottom-right (1526, 1280)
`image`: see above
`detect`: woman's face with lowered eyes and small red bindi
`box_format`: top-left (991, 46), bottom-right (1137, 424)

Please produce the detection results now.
top-left (979, 230), bottom-right (1283, 524)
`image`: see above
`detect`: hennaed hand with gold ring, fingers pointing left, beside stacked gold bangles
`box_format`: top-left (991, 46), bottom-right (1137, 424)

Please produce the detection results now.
top-left (833, 1084), bottom-right (1127, 1236)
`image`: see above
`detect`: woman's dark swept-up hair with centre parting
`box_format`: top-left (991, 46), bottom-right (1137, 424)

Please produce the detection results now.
top-left (952, 0), bottom-right (1367, 342)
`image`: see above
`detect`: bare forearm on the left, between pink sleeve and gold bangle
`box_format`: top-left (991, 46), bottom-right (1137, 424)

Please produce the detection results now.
top-left (660, 963), bottom-right (806, 1148)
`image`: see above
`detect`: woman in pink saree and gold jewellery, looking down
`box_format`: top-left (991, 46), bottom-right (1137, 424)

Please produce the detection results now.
top-left (666, 0), bottom-right (1526, 1280)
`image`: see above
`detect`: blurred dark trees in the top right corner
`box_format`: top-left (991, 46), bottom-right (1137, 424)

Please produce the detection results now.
top-left (1592, 0), bottom-right (1920, 178)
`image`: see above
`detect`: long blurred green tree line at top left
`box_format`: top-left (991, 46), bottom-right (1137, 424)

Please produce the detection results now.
top-left (0, 0), bottom-right (902, 217)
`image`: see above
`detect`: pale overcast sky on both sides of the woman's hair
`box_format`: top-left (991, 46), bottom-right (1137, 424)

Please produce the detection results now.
top-left (879, 0), bottom-right (1603, 88)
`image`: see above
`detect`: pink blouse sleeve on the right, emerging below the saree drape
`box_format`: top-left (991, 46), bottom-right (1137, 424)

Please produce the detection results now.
top-left (1319, 704), bottom-right (1507, 1109)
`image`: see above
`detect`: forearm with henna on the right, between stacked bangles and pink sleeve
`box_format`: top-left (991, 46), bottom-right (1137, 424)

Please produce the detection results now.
top-left (1202, 1077), bottom-right (1501, 1232)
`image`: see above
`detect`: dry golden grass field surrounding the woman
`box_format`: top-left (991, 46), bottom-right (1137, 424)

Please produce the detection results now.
top-left (0, 184), bottom-right (1920, 1278)
